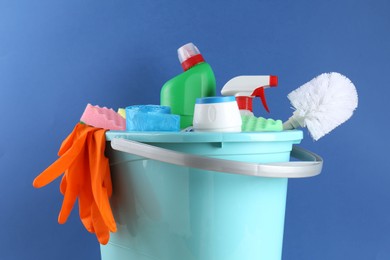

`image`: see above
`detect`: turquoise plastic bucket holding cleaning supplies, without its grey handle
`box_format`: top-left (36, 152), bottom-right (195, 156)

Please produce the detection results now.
top-left (101, 130), bottom-right (319, 260)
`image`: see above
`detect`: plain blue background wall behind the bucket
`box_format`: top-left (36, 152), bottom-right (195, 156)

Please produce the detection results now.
top-left (0, 0), bottom-right (390, 260)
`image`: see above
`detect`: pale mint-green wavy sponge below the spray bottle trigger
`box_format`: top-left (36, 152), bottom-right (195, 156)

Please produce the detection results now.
top-left (241, 115), bottom-right (283, 132)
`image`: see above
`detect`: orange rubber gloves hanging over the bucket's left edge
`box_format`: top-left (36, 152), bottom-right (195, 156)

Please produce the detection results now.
top-left (33, 123), bottom-right (117, 245)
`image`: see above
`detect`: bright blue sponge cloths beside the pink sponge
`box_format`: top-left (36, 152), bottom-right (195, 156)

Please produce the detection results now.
top-left (126, 105), bottom-right (180, 132)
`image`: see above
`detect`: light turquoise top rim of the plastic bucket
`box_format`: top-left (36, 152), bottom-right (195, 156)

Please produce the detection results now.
top-left (106, 130), bottom-right (303, 143)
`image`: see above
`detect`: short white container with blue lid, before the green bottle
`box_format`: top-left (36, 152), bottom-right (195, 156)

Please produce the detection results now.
top-left (193, 96), bottom-right (242, 132)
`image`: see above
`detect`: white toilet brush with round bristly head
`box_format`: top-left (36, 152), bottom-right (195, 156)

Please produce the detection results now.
top-left (283, 72), bottom-right (358, 141)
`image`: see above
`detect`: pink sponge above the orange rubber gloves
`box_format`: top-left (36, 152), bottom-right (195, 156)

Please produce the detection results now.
top-left (80, 104), bottom-right (126, 130)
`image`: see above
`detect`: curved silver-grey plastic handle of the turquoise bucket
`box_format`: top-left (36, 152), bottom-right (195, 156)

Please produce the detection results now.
top-left (111, 138), bottom-right (323, 178)
